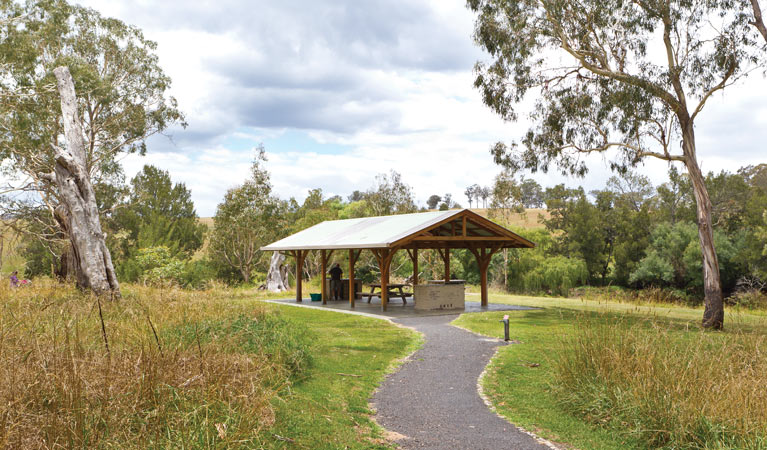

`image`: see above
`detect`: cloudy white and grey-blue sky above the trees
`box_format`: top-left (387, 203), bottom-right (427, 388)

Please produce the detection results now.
top-left (80, 0), bottom-right (767, 216)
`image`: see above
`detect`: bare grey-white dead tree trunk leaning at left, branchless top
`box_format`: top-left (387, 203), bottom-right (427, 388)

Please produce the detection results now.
top-left (46, 67), bottom-right (120, 297)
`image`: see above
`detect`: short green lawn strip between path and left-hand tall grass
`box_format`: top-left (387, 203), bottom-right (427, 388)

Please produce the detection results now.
top-left (268, 305), bottom-right (420, 449)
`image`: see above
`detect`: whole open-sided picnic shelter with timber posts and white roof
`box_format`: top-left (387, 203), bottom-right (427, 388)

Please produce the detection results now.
top-left (261, 209), bottom-right (535, 311)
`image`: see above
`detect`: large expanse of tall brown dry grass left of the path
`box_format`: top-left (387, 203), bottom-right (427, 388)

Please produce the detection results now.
top-left (0, 282), bottom-right (309, 449)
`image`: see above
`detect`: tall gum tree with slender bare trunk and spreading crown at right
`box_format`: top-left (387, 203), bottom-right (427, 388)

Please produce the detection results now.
top-left (467, 0), bottom-right (764, 329)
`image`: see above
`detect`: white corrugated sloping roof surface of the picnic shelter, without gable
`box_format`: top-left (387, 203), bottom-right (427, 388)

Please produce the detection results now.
top-left (261, 209), bottom-right (463, 251)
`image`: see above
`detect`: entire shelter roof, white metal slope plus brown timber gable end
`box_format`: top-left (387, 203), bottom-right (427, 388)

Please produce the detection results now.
top-left (261, 209), bottom-right (535, 251)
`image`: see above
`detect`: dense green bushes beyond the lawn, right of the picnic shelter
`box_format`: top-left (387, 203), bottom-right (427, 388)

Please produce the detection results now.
top-left (491, 164), bottom-right (767, 304)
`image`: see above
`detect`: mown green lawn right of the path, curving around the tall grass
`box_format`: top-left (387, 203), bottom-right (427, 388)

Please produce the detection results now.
top-left (453, 294), bottom-right (767, 449)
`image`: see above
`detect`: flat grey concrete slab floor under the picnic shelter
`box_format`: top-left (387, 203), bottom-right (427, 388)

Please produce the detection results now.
top-left (269, 297), bottom-right (539, 319)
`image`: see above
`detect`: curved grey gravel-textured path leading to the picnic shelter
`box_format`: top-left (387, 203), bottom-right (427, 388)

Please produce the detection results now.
top-left (373, 315), bottom-right (549, 450)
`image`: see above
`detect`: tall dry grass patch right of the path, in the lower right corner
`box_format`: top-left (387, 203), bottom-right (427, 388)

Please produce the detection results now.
top-left (553, 316), bottom-right (767, 449)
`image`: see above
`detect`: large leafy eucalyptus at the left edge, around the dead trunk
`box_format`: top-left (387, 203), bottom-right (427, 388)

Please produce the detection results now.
top-left (0, 0), bottom-right (183, 292)
